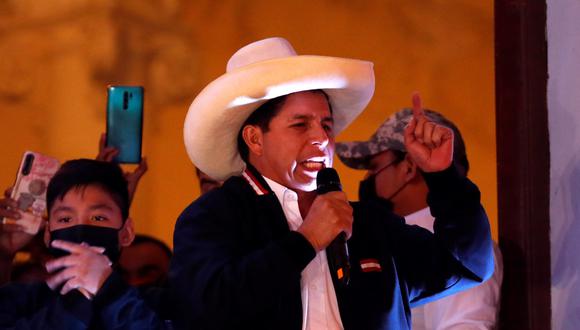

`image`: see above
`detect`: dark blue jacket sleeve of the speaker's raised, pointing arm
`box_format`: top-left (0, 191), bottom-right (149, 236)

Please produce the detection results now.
top-left (393, 167), bottom-right (494, 307)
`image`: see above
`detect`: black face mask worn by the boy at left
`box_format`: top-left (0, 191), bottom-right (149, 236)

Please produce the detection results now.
top-left (49, 225), bottom-right (121, 263)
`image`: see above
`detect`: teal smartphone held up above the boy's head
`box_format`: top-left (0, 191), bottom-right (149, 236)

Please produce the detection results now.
top-left (107, 86), bottom-right (143, 164)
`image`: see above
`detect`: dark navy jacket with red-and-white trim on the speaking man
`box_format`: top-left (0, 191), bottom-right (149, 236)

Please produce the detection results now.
top-left (170, 168), bottom-right (493, 329)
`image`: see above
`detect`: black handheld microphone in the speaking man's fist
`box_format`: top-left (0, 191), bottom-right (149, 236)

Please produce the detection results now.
top-left (316, 168), bottom-right (350, 285)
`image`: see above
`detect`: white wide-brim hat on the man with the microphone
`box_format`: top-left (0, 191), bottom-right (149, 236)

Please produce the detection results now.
top-left (183, 38), bottom-right (375, 180)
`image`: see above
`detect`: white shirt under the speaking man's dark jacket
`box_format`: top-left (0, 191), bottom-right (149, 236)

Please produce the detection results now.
top-left (264, 177), bottom-right (343, 330)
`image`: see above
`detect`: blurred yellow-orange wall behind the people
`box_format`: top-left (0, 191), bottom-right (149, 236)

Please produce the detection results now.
top-left (0, 0), bottom-right (497, 248)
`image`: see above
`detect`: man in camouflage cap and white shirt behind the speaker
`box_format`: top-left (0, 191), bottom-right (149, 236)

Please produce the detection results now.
top-left (336, 108), bottom-right (503, 330)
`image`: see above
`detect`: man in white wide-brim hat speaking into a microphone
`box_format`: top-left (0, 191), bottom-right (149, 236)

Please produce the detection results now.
top-left (170, 38), bottom-right (493, 329)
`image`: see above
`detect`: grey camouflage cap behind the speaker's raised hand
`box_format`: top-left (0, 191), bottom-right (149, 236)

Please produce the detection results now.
top-left (336, 108), bottom-right (469, 172)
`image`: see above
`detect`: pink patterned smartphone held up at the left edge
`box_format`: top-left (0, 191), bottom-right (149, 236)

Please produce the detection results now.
top-left (11, 151), bottom-right (60, 235)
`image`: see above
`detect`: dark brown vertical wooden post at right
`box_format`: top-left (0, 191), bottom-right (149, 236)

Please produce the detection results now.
top-left (494, 0), bottom-right (551, 330)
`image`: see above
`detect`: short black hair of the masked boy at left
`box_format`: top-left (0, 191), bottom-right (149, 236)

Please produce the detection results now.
top-left (46, 159), bottom-right (129, 221)
